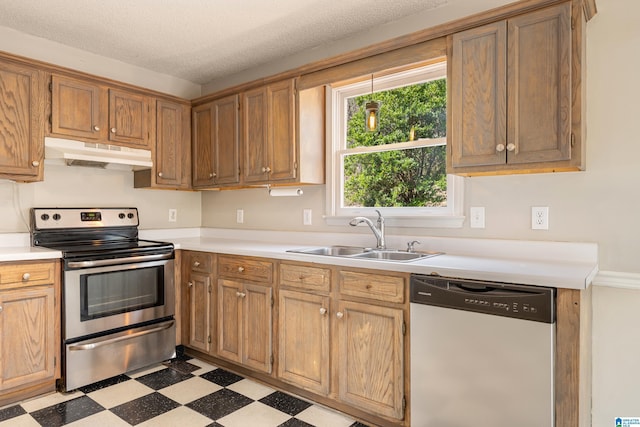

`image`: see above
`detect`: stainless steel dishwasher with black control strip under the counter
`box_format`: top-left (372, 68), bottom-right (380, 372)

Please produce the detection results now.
top-left (410, 274), bottom-right (556, 427)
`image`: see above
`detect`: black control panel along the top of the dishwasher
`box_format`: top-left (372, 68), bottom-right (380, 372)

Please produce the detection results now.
top-left (410, 274), bottom-right (556, 323)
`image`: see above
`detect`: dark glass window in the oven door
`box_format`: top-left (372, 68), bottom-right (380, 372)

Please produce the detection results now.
top-left (80, 265), bottom-right (164, 321)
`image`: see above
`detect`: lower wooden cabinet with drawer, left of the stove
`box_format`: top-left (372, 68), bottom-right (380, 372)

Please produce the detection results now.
top-left (0, 261), bottom-right (60, 406)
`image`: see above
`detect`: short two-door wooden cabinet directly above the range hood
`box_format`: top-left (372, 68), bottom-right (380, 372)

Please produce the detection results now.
top-left (51, 74), bottom-right (155, 148)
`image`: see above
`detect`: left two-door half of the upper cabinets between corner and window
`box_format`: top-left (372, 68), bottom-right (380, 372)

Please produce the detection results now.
top-left (192, 95), bottom-right (240, 188)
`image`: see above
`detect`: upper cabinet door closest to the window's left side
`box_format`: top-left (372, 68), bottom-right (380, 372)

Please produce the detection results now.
top-left (267, 79), bottom-right (297, 181)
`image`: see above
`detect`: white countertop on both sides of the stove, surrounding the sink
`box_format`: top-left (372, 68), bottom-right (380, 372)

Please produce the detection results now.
top-left (0, 228), bottom-right (598, 289)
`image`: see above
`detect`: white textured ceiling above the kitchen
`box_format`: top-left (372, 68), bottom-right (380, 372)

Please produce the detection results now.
top-left (0, 0), bottom-right (454, 84)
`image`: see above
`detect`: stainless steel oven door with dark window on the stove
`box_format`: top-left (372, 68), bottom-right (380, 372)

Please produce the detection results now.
top-left (63, 259), bottom-right (175, 342)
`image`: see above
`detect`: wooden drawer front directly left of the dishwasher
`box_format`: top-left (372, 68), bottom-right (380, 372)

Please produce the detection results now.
top-left (339, 271), bottom-right (405, 303)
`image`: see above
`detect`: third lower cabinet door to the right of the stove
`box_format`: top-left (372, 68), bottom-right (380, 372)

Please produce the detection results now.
top-left (240, 283), bottom-right (273, 373)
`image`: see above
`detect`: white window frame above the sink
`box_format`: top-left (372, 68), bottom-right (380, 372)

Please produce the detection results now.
top-left (325, 62), bottom-right (464, 228)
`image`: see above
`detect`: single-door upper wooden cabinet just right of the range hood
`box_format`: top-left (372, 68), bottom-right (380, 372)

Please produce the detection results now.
top-left (134, 99), bottom-right (191, 189)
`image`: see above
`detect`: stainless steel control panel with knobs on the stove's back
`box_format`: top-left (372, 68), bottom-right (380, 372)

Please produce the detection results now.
top-left (31, 208), bottom-right (140, 230)
